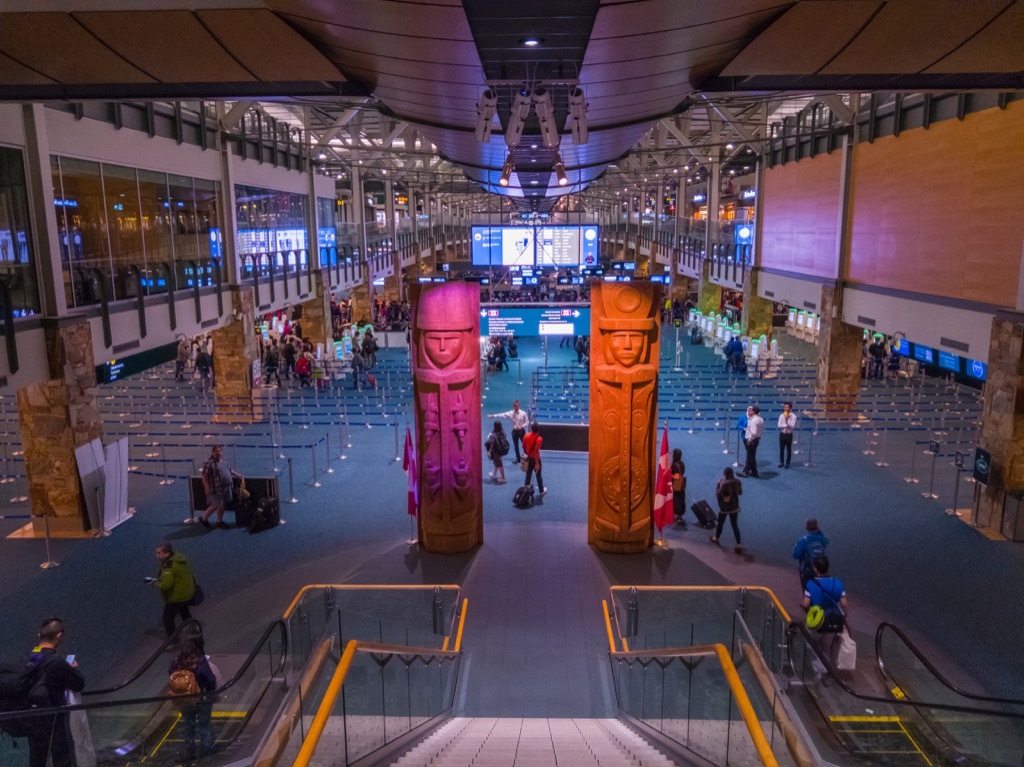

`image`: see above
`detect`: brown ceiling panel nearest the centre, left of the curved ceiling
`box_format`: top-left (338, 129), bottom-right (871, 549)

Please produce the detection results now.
top-left (196, 9), bottom-right (345, 82)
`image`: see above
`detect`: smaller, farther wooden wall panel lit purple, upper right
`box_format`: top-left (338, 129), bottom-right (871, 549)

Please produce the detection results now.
top-left (760, 152), bottom-right (842, 279)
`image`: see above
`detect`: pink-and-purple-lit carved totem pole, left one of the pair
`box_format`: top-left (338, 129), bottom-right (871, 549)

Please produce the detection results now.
top-left (412, 283), bottom-right (483, 554)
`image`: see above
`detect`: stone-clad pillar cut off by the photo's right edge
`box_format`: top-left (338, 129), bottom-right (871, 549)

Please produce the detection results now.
top-left (977, 312), bottom-right (1024, 541)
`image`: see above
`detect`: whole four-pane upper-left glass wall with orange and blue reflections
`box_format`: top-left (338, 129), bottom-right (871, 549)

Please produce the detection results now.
top-left (50, 157), bottom-right (220, 306)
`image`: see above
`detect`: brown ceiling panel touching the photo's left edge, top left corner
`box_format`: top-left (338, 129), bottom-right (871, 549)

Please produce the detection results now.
top-left (0, 13), bottom-right (153, 84)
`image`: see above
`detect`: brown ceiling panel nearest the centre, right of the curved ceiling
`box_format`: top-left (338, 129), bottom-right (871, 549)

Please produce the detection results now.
top-left (722, 0), bottom-right (882, 77)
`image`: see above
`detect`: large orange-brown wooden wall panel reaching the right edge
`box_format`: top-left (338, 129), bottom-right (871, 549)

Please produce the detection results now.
top-left (849, 102), bottom-right (1024, 306)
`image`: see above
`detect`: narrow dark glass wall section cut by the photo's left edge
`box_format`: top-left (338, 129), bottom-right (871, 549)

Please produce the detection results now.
top-left (0, 146), bottom-right (39, 316)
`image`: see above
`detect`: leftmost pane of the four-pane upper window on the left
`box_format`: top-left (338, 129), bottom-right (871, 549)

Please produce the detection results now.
top-left (53, 158), bottom-right (111, 306)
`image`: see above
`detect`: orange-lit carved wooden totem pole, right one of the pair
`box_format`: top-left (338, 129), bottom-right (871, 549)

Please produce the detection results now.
top-left (587, 281), bottom-right (660, 554)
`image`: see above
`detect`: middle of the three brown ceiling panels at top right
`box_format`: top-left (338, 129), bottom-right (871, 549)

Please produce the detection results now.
top-left (821, 0), bottom-right (1007, 75)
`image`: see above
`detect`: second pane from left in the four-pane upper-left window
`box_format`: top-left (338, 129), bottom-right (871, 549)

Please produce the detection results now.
top-left (103, 165), bottom-right (145, 300)
